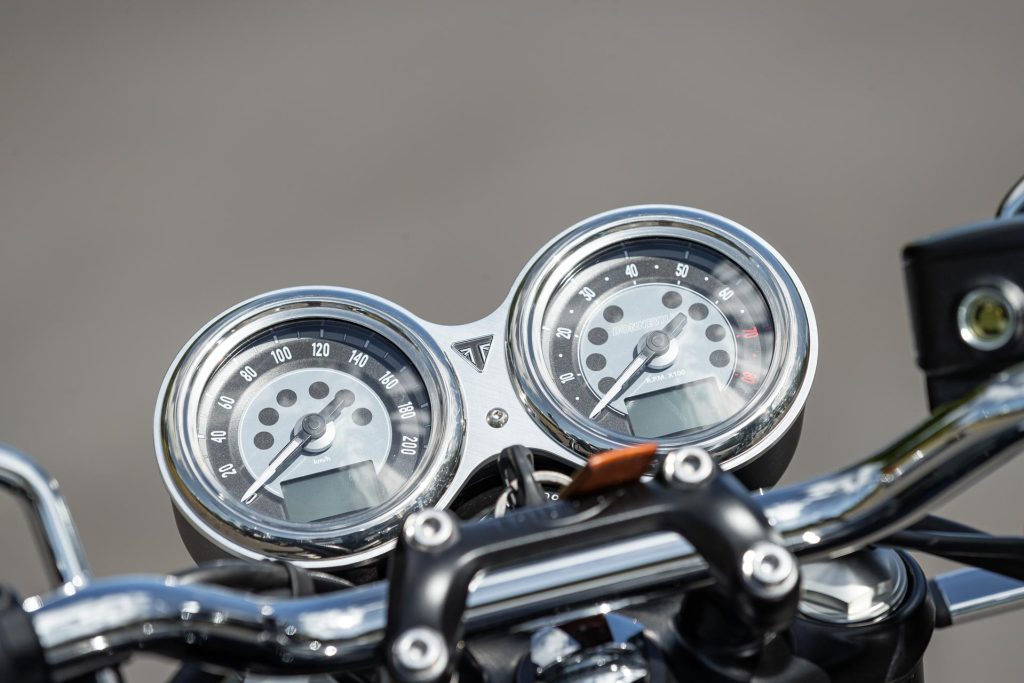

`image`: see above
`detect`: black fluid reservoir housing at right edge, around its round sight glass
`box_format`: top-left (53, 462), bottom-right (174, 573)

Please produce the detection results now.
top-left (903, 216), bottom-right (1024, 409)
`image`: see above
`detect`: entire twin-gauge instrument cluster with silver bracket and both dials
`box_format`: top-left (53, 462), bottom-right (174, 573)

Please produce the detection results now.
top-left (155, 206), bottom-right (817, 568)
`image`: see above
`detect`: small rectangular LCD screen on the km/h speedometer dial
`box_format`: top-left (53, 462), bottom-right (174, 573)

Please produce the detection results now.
top-left (281, 460), bottom-right (385, 522)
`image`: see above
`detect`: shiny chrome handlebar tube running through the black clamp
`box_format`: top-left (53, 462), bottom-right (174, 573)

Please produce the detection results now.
top-left (9, 366), bottom-right (1024, 679)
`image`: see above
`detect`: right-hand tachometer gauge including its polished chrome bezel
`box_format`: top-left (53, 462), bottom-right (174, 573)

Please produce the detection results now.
top-left (509, 206), bottom-right (816, 467)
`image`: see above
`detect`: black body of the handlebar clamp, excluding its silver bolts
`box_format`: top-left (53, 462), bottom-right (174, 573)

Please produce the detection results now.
top-left (384, 456), bottom-right (799, 683)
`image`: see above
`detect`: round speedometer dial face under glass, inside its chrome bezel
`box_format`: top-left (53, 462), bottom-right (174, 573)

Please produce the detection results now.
top-left (197, 318), bottom-right (432, 525)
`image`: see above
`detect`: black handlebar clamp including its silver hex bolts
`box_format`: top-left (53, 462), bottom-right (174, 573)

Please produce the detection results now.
top-left (385, 449), bottom-right (799, 683)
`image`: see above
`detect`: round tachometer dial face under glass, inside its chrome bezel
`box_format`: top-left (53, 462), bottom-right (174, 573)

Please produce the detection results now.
top-left (540, 238), bottom-right (775, 439)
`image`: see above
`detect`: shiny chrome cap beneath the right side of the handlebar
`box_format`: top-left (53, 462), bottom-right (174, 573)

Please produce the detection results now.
top-left (800, 548), bottom-right (909, 625)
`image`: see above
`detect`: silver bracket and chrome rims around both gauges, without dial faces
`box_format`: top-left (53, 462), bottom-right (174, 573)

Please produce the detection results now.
top-left (155, 207), bottom-right (816, 568)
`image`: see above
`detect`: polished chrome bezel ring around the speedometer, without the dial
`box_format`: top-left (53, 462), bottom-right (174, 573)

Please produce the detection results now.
top-left (154, 287), bottom-right (465, 568)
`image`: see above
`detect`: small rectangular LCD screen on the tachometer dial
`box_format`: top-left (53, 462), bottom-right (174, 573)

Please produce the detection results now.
top-left (626, 378), bottom-right (733, 438)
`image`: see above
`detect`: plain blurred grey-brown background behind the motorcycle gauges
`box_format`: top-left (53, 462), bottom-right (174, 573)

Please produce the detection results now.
top-left (0, 1), bottom-right (1024, 682)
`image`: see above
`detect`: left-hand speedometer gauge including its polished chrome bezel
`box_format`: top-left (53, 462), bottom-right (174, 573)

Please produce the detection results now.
top-left (157, 288), bottom-right (462, 567)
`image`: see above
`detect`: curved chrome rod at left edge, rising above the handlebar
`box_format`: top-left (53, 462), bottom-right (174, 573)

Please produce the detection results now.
top-left (0, 444), bottom-right (90, 593)
